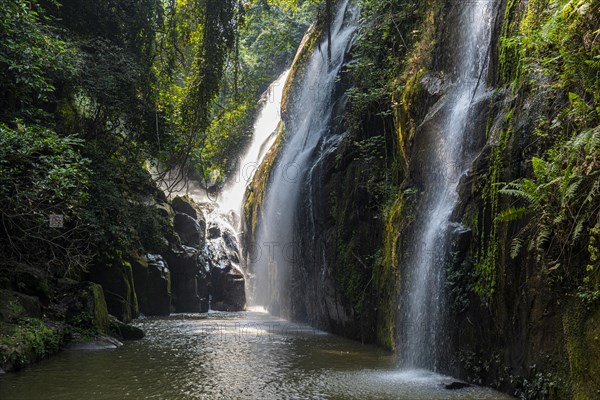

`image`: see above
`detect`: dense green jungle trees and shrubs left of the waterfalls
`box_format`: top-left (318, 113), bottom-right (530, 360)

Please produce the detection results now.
top-left (0, 0), bottom-right (322, 367)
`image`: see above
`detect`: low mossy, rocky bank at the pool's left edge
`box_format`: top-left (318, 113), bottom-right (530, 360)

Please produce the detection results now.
top-left (0, 264), bottom-right (144, 373)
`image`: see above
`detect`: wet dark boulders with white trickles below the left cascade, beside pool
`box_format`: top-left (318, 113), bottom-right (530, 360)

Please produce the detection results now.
top-left (162, 196), bottom-right (246, 315)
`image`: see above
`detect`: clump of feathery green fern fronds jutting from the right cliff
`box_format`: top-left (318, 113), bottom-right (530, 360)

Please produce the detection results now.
top-left (498, 128), bottom-right (600, 290)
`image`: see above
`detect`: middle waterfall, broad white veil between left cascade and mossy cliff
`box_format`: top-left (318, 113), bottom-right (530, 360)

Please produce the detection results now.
top-left (251, 0), bottom-right (358, 317)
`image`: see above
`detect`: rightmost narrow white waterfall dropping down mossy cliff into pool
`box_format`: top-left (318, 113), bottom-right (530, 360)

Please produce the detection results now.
top-left (399, 1), bottom-right (493, 370)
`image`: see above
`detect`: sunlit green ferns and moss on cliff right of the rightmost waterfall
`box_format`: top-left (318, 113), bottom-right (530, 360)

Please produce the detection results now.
top-left (477, 0), bottom-right (600, 299)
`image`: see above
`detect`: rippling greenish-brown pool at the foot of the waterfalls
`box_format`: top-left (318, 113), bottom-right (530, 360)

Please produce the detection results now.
top-left (0, 311), bottom-right (508, 400)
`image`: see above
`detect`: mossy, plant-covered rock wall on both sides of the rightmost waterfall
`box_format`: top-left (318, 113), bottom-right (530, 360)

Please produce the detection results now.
top-left (246, 0), bottom-right (600, 399)
